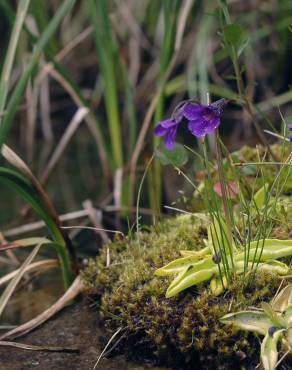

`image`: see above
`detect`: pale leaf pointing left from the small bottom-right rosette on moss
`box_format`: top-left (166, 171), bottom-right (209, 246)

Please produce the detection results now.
top-left (220, 311), bottom-right (273, 335)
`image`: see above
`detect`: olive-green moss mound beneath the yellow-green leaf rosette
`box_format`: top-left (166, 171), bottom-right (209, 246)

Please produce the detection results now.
top-left (82, 143), bottom-right (292, 369)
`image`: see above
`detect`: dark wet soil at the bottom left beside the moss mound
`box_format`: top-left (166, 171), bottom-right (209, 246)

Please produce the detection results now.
top-left (0, 302), bottom-right (167, 370)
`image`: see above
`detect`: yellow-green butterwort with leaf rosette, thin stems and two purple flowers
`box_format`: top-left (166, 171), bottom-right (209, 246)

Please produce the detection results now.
top-left (155, 99), bottom-right (292, 298)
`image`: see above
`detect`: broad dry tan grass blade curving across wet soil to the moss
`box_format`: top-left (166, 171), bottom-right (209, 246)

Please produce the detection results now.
top-left (0, 276), bottom-right (84, 340)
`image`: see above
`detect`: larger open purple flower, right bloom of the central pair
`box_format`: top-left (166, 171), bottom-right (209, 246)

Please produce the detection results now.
top-left (183, 99), bottom-right (227, 137)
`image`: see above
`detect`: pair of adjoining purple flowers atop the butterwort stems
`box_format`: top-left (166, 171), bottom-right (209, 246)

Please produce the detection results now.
top-left (154, 99), bottom-right (227, 150)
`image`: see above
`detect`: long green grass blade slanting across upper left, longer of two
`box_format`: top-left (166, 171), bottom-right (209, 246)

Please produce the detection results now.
top-left (0, 0), bottom-right (76, 148)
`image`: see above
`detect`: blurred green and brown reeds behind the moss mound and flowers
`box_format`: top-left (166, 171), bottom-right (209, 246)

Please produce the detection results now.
top-left (0, 0), bottom-right (292, 328)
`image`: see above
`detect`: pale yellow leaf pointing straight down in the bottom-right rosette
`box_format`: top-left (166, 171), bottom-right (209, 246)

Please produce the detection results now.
top-left (261, 330), bottom-right (283, 370)
